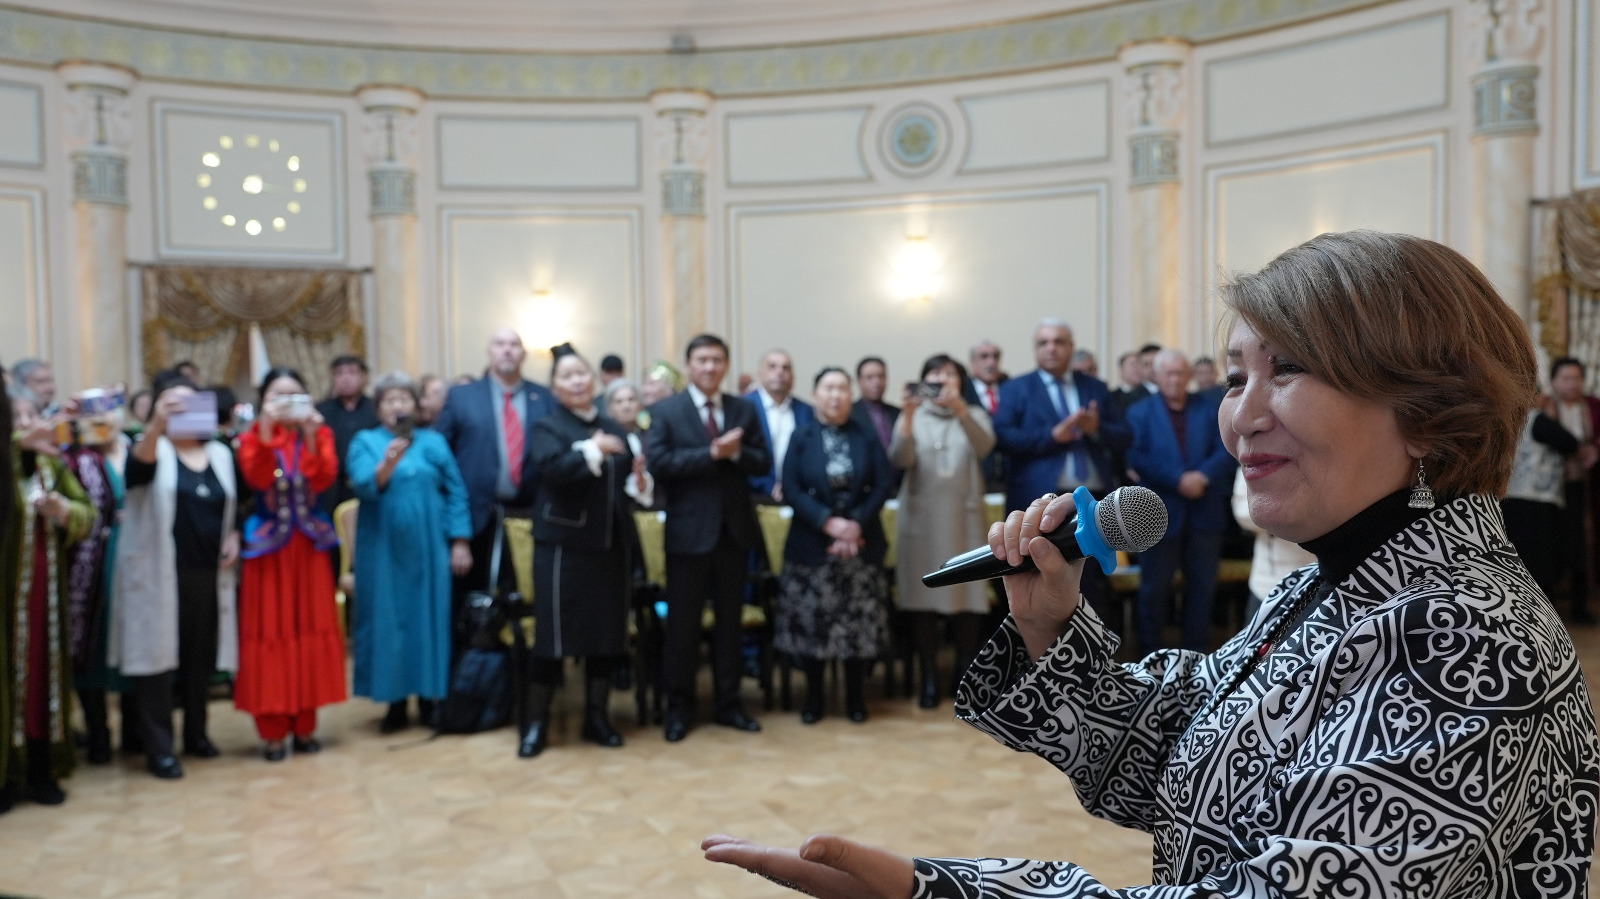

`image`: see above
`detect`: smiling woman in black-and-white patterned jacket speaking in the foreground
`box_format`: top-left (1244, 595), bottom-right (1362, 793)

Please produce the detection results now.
top-left (706, 232), bottom-right (1600, 899)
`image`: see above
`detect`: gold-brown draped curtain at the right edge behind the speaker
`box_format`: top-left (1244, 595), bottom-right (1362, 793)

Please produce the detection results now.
top-left (1533, 190), bottom-right (1600, 394)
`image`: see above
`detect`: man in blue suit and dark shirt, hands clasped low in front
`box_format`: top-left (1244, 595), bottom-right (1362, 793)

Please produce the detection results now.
top-left (1128, 349), bottom-right (1235, 654)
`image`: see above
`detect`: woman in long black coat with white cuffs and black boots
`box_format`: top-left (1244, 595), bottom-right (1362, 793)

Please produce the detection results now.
top-left (517, 344), bottom-right (638, 758)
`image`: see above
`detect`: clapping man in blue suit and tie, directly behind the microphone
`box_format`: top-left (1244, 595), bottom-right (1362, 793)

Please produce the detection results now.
top-left (994, 318), bottom-right (1133, 630)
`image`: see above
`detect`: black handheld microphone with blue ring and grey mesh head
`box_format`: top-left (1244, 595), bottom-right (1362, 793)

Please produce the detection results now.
top-left (922, 486), bottom-right (1166, 587)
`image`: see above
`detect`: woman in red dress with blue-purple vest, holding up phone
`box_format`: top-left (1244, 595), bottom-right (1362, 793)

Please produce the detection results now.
top-left (234, 368), bottom-right (346, 761)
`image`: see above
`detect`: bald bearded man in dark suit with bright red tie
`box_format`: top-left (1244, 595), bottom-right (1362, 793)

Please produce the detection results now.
top-left (434, 328), bottom-right (555, 608)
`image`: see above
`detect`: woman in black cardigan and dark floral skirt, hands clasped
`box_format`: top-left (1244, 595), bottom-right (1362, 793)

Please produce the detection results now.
top-left (773, 366), bottom-right (894, 725)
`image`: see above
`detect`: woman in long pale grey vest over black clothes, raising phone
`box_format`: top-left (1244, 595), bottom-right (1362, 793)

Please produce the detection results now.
top-left (109, 373), bottom-right (240, 779)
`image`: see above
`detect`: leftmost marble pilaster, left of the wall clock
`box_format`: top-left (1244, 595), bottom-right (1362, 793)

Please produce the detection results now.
top-left (56, 62), bottom-right (138, 387)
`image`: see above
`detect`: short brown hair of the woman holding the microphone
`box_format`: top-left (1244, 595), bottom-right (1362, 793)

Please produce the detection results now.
top-left (1222, 230), bottom-right (1539, 497)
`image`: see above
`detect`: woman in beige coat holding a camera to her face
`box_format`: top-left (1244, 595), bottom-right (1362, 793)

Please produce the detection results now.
top-left (890, 354), bottom-right (995, 709)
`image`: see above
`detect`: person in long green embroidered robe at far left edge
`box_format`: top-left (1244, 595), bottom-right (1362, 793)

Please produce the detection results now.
top-left (0, 394), bottom-right (94, 813)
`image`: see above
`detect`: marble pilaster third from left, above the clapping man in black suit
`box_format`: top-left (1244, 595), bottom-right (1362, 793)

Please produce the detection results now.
top-left (645, 91), bottom-right (712, 360)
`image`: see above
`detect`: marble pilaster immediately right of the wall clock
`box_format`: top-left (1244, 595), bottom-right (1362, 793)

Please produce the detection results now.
top-left (355, 86), bottom-right (437, 374)
